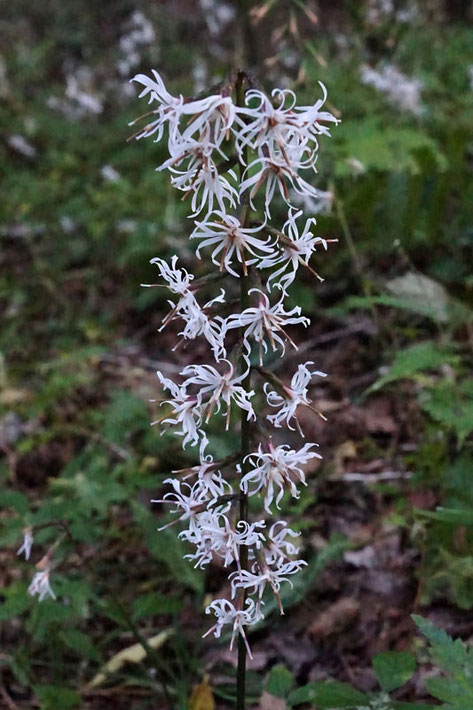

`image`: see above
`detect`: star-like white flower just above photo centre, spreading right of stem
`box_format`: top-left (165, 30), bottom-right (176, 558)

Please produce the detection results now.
top-left (225, 288), bottom-right (310, 365)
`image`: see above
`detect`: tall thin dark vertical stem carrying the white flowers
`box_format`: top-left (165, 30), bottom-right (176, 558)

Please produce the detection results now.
top-left (235, 71), bottom-right (251, 710)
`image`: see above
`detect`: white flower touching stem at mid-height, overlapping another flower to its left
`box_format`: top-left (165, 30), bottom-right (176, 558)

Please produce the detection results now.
top-left (181, 360), bottom-right (256, 429)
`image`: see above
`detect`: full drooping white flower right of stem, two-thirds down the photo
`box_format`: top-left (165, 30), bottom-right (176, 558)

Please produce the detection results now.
top-left (240, 441), bottom-right (322, 513)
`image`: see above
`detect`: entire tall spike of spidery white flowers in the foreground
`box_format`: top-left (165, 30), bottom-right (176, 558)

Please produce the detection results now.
top-left (134, 71), bottom-right (338, 652)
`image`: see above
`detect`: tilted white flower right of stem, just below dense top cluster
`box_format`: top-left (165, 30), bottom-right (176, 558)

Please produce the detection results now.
top-left (258, 209), bottom-right (328, 293)
